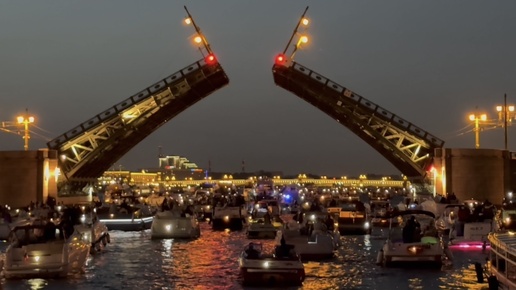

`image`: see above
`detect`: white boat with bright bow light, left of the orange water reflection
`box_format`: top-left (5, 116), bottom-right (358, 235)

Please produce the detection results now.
top-left (151, 210), bottom-right (201, 239)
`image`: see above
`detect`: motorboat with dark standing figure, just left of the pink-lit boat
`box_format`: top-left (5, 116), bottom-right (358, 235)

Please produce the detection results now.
top-left (377, 210), bottom-right (452, 267)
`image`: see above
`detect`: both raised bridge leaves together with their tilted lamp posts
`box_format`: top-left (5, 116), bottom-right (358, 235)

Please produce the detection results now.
top-left (47, 6), bottom-right (444, 194)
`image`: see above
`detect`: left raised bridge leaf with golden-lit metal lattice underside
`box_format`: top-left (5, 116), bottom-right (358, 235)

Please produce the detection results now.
top-left (47, 60), bottom-right (229, 181)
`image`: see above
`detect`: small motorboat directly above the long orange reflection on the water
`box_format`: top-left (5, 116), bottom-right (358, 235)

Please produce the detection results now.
top-left (211, 205), bottom-right (246, 231)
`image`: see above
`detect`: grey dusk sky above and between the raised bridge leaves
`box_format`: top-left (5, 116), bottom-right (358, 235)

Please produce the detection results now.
top-left (0, 0), bottom-right (516, 176)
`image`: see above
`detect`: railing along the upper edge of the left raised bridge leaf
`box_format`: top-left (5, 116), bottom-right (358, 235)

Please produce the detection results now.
top-left (47, 59), bottom-right (212, 149)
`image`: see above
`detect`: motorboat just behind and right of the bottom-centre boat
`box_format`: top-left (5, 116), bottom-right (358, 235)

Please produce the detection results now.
top-left (275, 212), bottom-right (340, 260)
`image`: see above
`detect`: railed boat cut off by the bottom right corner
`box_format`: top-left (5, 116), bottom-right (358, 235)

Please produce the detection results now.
top-left (487, 232), bottom-right (516, 290)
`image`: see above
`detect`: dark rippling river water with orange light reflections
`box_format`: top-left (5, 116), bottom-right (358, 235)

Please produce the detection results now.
top-left (0, 223), bottom-right (488, 290)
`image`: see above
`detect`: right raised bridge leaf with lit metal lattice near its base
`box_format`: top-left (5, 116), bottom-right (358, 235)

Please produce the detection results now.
top-left (272, 62), bottom-right (444, 177)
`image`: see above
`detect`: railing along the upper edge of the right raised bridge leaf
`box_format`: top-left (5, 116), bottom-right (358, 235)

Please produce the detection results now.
top-left (291, 62), bottom-right (444, 147)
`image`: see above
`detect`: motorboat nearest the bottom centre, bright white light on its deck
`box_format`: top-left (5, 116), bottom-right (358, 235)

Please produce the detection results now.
top-left (238, 242), bottom-right (305, 286)
